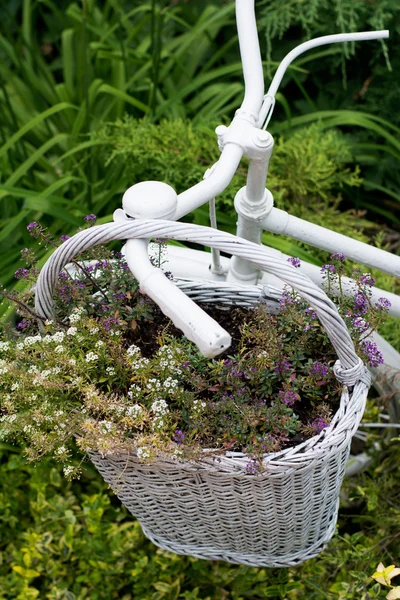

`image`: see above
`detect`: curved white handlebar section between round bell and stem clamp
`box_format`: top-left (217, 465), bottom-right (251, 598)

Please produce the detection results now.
top-left (172, 143), bottom-right (243, 221)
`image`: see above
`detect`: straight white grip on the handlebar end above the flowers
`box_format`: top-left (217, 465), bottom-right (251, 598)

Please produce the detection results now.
top-left (140, 269), bottom-right (232, 357)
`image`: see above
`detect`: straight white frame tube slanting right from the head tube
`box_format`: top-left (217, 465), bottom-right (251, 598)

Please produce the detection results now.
top-left (262, 208), bottom-right (400, 277)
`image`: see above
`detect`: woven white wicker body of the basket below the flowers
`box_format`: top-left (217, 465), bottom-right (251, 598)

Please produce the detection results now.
top-left (91, 447), bottom-right (348, 567)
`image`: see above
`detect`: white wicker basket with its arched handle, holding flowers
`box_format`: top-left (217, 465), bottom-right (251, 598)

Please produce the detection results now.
top-left (36, 220), bottom-right (370, 567)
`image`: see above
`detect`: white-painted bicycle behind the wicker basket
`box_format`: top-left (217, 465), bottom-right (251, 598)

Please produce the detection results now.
top-left (43, 0), bottom-right (400, 473)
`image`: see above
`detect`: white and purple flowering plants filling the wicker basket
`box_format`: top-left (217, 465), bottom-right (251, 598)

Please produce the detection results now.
top-left (0, 220), bottom-right (390, 478)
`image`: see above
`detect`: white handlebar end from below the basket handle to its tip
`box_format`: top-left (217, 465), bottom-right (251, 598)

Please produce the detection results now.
top-left (125, 239), bottom-right (231, 357)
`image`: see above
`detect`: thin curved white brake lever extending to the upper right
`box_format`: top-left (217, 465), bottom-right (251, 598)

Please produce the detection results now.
top-left (257, 29), bottom-right (389, 127)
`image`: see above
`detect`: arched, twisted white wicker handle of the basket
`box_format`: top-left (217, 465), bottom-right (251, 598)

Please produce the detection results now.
top-left (35, 219), bottom-right (370, 386)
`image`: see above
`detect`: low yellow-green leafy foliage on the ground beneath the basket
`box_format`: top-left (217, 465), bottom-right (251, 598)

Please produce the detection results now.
top-left (0, 434), bottom-right (400, 600)
